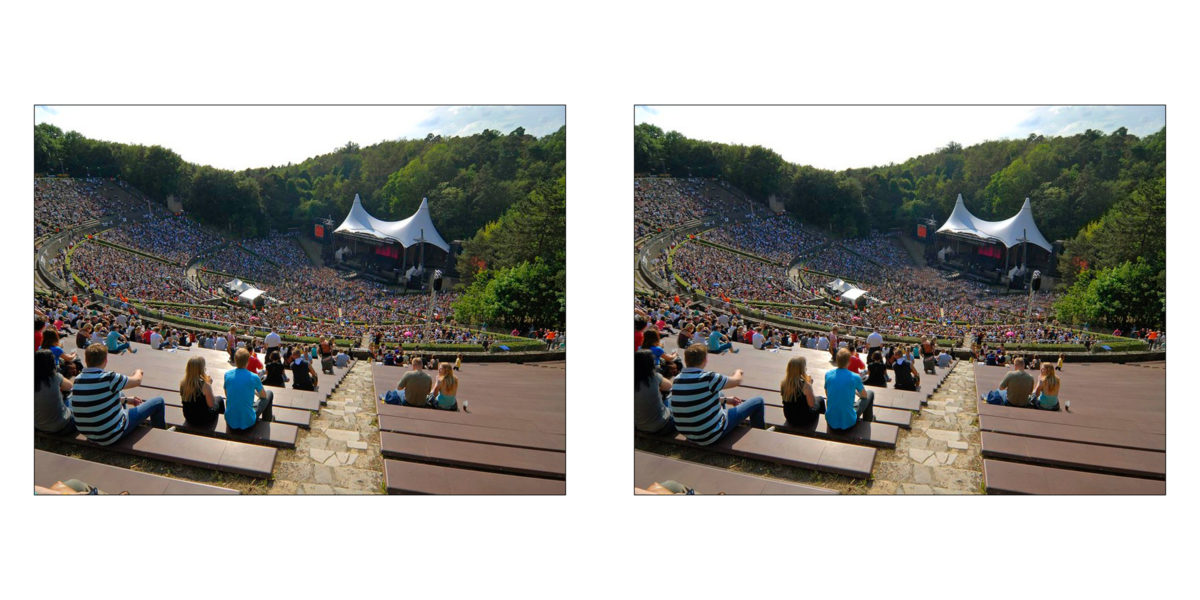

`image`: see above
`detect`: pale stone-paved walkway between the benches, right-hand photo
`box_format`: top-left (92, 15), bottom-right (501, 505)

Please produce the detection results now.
top-left (868, 361), bottom-right (983, 494)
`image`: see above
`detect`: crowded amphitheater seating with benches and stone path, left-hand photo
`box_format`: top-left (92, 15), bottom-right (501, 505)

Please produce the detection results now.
top-left (34, 178), bottom-right (566, 494)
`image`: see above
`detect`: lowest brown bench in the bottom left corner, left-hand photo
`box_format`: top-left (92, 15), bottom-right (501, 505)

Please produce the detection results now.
top-left (34, 449), bottom-right (238, 496)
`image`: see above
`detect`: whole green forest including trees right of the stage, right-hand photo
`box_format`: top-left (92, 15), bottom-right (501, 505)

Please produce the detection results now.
top-left (634, 124), bottom-right (1166, 325)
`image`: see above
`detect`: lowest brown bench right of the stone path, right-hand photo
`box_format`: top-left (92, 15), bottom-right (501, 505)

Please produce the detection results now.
top-left (983, 460), bottom-right (1166, 494)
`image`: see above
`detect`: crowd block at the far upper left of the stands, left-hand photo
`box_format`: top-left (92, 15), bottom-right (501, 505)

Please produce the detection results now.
top-left (34, 178), bottom-right (138, 238)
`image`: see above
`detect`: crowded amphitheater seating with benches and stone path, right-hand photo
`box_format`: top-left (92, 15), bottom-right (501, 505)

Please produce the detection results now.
top-left (634, 178), bottom-right (1166, 494)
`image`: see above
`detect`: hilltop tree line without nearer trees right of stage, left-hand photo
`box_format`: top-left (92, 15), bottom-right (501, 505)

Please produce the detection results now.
top-left (34, 124), bottom-right (566, 240)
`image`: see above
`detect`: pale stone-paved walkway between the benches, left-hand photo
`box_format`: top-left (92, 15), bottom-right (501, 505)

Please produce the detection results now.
top-left (268, 360), bottom-right (384, 494)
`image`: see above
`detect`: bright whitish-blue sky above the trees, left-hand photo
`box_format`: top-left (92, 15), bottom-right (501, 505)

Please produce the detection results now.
top-left (34, 106), bottom-right (566, 170)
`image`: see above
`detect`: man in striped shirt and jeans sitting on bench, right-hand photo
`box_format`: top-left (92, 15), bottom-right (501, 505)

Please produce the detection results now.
top-left (668, 343), bottom-right (767, 445)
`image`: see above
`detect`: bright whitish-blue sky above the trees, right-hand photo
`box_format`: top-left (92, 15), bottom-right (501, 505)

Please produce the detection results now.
top-left (635, 106), bottom-right (1166, 170)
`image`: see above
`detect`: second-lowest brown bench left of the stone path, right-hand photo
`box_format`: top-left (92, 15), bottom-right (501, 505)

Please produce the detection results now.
top-left (637, 427), bottom-right (875, 479)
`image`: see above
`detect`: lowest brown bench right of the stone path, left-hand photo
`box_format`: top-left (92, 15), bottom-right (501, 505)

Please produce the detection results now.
top-left (383, 460), bottom-right (566, 496)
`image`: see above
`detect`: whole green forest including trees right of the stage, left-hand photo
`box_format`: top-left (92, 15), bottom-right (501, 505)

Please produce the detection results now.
top-left (34, 124), bottom-right (566, 326)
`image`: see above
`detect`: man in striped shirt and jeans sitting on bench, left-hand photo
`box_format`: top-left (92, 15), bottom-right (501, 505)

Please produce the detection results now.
top-left (71, 343), bottom-right (167, 445)
